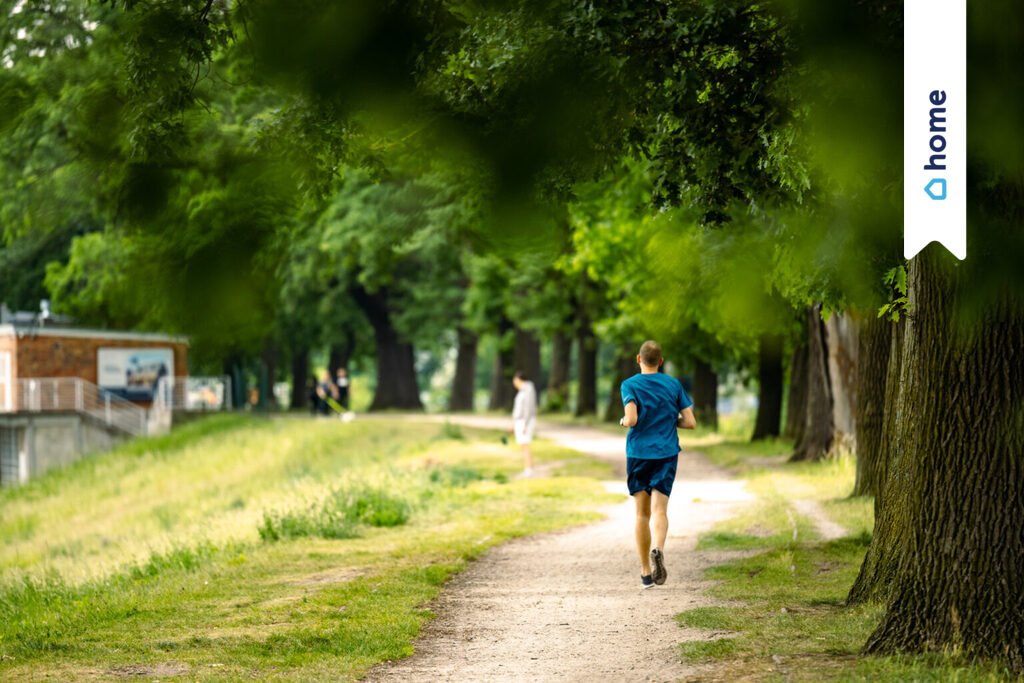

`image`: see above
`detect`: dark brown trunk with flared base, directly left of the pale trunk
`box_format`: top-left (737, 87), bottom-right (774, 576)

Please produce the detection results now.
top-left (790, 304), bottom-right (835, 461)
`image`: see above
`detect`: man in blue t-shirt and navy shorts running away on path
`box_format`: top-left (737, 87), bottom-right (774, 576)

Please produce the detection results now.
top-left (618, 341), bottom-right (697, 588)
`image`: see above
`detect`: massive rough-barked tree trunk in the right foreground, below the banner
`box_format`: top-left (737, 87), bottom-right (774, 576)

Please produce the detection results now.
top-left (865, 246), bottom-right (1024, 673)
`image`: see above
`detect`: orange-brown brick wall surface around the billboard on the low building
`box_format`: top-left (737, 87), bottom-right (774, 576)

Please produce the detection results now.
top-left (14, 335), bottom-right (188, 384)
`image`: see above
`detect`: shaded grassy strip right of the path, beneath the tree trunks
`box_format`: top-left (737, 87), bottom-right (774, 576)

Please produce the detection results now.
top-left (679, 434), bottom-right (1019, 682)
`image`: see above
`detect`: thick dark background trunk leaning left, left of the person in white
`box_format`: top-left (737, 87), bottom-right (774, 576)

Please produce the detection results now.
top-left (350, 286), bottom-right (423, 411)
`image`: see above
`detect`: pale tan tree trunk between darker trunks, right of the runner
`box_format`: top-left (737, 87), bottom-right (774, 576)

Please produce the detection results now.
top-left (825, 313), bottom-right (858, 454)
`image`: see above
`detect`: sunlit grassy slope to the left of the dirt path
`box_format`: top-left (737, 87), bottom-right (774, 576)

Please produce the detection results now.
top-left (0, 418), bottom-right (613, 680)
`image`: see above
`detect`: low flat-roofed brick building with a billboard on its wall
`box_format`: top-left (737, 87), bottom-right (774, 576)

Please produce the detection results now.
top-left (0, 323), bottom-right (188, 411)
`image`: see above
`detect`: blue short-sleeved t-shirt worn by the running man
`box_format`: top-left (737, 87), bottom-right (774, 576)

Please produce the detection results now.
top-left (622, 373), bottom-right (693, 460)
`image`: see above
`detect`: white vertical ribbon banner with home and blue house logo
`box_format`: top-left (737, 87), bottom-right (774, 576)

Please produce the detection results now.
top-left (903, 0), bottom-right (967, 260)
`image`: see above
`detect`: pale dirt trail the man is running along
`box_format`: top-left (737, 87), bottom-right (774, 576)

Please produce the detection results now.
top-left (368, 417), bottom-right (751, 682)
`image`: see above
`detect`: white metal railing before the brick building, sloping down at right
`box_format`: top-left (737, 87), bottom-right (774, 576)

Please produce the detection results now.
top-left (13, 377), bottom-right (148, 436)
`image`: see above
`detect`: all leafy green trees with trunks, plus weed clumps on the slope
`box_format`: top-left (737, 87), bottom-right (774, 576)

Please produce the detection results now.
top-left (0, 0), bottom-right (1024, 672)
